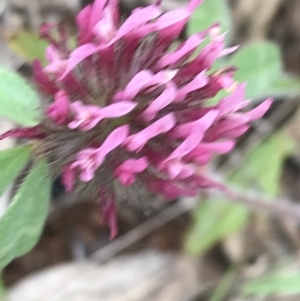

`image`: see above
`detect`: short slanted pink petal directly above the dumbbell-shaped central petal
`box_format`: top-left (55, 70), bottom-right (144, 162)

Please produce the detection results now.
top-left (142, 82), bottom-right (176, 121)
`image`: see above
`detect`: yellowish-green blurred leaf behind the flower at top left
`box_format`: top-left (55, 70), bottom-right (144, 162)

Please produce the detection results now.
top-left (8, 31), bottom-right (48, 63)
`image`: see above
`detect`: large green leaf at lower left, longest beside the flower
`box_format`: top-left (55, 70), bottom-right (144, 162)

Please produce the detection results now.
top-left (0, 159), bottom-right (50, 268)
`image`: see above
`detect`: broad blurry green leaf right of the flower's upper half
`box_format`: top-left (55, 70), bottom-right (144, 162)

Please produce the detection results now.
top-left (226, 41), bottom-right (300, 100)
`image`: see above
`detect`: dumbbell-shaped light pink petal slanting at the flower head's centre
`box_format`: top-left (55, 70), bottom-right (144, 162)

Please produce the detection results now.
top-left (124, 113), bottom-right (176, 151)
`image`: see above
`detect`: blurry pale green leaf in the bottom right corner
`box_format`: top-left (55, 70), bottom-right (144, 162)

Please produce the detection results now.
top-left (242, 272), bottom-right (300, 296)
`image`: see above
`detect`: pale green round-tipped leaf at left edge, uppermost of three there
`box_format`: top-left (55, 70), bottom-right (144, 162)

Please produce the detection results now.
top-left (0, 67), bottom-right (40, 126)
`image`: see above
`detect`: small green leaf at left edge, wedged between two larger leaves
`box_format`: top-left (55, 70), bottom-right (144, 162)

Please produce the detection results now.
top-left (0, 145), bottom-right (31, 195)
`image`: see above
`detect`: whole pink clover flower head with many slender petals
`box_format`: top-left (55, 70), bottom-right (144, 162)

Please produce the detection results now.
top-left (0, 0), bottom-right (271, 237)
